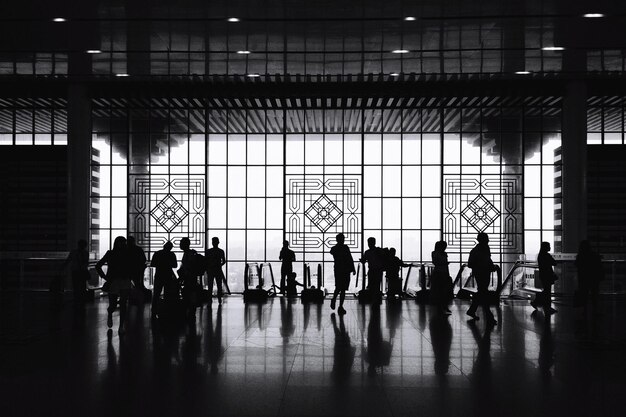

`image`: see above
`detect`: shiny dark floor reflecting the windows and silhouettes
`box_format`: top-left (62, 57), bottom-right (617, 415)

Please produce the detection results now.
top-left (0, 294), bottom-right (626, 416)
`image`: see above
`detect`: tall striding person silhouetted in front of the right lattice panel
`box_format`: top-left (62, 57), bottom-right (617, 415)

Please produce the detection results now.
top-left (467, 233), bottom-right (498, 326)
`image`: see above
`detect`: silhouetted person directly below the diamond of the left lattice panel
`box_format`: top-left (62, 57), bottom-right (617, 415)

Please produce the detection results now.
top-left (150, 241), bottom-right (178, 318)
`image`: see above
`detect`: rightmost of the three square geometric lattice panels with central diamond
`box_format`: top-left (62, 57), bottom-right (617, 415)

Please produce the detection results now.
top-left (443, 174), bottom-right (523, 254)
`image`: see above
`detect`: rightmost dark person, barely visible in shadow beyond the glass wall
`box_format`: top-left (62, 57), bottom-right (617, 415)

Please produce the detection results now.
top-left (575, 240), bottom-right (604, 314)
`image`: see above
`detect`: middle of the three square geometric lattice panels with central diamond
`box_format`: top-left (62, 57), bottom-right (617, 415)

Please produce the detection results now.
top-left (285, 174), bottom-right (362, 252)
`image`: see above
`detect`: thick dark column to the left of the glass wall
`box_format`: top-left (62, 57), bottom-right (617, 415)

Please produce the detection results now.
top-left (67, 84), bottom-right (91, 248)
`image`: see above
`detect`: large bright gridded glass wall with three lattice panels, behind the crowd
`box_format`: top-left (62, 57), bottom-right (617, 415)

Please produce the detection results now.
top-left (92, 97), bottom-right (561, 291)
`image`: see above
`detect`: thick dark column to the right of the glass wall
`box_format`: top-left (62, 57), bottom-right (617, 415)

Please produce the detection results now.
top-left (561, 81), bottom-right (587, 252)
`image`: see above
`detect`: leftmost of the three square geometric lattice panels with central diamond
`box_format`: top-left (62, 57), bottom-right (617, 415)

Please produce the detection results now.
top-left (128, 174), bottom-right (206, 252)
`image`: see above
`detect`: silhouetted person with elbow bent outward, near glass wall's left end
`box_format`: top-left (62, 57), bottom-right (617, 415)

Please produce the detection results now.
top-left (96, 236), bottom-right (132, 334)
